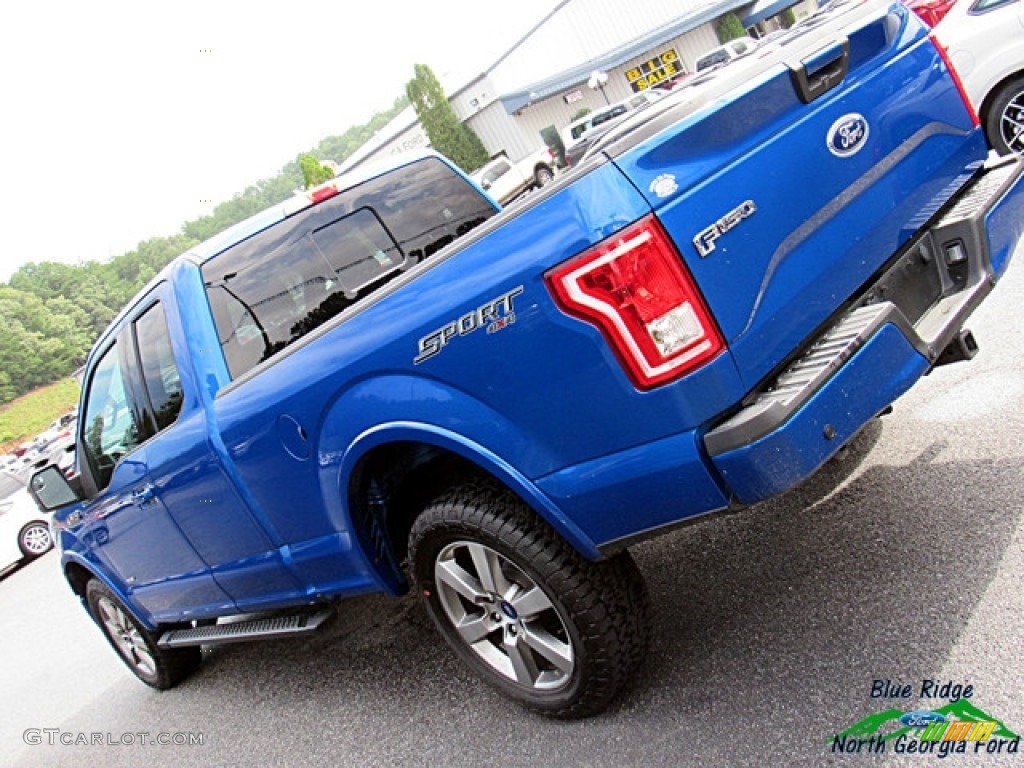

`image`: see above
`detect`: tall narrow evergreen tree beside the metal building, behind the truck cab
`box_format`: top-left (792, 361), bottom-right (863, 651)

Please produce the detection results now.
top-left (406, 65), bottom-right (489, 173)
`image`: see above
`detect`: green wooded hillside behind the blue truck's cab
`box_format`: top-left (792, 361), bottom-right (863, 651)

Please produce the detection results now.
top-left (0, 96), bottom-right (409, 405)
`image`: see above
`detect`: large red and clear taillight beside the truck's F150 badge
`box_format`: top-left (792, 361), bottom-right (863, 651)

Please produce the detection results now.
top-left (547, 216), bottom-right (725, 389)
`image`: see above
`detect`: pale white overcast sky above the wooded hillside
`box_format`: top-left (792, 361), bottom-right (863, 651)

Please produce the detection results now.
top-left (0, 0), bottom-right (557, 281)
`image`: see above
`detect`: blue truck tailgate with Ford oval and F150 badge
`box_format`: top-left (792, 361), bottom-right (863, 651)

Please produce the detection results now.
top-left (605, 3), bottom-right (985, 387)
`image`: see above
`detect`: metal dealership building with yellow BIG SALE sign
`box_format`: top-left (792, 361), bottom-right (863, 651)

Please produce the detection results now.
top-left (341, 0), bottom-right (817, 171)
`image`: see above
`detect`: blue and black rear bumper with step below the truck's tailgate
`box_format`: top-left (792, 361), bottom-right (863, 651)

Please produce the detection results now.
top-left (705, 158), bottom-right (1024, 504)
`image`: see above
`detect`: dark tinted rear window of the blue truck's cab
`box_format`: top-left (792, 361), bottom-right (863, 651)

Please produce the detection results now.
top-left (203, 158), bottom-right (496, 378)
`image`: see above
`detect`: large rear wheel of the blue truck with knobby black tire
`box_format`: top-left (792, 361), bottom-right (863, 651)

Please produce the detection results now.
top-left (410, 481), bottom-right (649, 719)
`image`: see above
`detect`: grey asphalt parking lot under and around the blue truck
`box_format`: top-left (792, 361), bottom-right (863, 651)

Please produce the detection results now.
top-left (0, 247), bottom-right (1024, 768)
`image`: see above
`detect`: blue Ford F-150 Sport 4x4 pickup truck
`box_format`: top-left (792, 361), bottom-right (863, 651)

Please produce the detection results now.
top-left (32, 1), bottom-right (1024, 717)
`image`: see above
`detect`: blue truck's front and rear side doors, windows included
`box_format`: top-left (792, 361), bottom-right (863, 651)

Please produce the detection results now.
top-left (75, 286), bottom-right (302, 622)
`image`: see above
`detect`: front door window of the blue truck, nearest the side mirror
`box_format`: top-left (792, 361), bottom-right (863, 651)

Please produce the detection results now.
top-left (82, 344), bottom-right (141, 488)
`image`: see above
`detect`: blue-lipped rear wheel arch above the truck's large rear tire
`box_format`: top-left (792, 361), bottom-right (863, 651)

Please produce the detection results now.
top-left (339, 422), bottom-right (601, 590)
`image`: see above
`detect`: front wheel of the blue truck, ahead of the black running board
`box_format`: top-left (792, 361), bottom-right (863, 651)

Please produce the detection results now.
top-left (85, 579), bottom-right (202, 690)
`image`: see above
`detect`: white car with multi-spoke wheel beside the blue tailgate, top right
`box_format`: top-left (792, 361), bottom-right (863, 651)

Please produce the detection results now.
top-left (907, 0), bottom-right (1024, 155)
